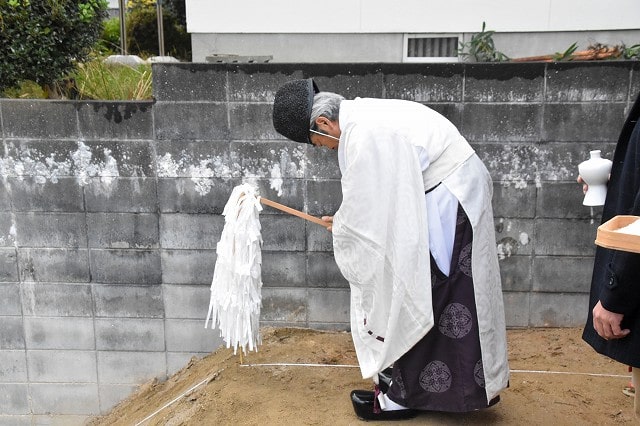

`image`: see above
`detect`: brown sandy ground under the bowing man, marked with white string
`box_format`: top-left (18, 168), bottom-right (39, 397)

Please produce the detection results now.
top-left (91, 328), bottom-right (640, 426)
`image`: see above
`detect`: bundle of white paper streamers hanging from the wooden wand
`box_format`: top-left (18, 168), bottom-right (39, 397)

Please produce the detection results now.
top-left (204, 184), bottom-right (262, 354)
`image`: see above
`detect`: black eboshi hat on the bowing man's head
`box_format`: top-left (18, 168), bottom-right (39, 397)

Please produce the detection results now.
top-left (273, 78), bottom-right (320, 143)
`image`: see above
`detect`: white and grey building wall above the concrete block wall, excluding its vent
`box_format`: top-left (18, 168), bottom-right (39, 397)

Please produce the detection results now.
top-left (186, 0), bottom-right (640, 62)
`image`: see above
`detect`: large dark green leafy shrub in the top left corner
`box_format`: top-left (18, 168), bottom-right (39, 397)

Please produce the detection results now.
top-left (0, 0), bottom-right (107, 97)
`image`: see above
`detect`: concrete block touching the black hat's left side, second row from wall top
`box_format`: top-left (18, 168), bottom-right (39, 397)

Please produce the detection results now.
top-left (229, 103), bottom-right (282, 141)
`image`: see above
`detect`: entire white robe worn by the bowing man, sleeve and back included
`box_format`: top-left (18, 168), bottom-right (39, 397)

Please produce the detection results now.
top-left (333, 98), bottom-right (509, 401)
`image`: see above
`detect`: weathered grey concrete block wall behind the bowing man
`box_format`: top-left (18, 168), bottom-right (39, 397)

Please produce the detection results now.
top-left (0, 62), bottom-right (640, 425)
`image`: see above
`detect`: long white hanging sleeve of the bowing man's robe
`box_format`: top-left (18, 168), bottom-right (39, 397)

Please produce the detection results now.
top-left (333, 124), bottom-right (433, 378)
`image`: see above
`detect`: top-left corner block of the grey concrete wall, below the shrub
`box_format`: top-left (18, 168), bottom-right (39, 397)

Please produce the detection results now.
top-left (2, 99), bottom-right (78, 139)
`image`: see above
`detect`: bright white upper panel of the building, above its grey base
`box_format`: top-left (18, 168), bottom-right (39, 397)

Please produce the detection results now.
top-left (186, 0), bottom-right (640, 33)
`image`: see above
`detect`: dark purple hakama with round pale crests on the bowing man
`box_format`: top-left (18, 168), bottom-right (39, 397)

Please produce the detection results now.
top-left (387, 206), bottom-right (497, 412)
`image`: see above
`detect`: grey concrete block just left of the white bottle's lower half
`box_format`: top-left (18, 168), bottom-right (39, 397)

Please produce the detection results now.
top-left (536, 181), bottom-right (602, 219)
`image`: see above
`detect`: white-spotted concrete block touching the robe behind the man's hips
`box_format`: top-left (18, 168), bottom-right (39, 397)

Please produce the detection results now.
top-left (494, 218), bottom-right (537, 260)
